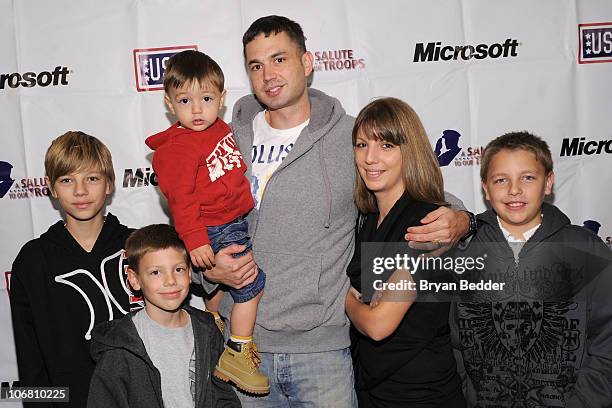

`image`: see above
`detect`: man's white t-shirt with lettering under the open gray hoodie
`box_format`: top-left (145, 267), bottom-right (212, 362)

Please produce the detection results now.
top-left (251, 111), bottom-right (310, 208)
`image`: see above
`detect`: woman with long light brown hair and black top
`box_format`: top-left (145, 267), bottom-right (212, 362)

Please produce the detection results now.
top-left (346, 98), bottom-right (465, 408)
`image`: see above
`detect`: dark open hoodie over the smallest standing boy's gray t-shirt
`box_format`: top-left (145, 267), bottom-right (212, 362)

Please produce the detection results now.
top-left (83, 306), bottom-right (240, 408)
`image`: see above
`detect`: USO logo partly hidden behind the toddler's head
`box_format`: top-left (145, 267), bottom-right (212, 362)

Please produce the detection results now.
top-left (134, 45), bottom-right (198, 92)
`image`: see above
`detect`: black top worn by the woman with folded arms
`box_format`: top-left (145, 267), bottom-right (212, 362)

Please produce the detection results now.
top-left (347, 193), bottom-right (465, 407)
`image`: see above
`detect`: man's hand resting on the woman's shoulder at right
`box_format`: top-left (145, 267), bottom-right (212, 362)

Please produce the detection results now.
top-left (404, 207), bottom-right (470, 249)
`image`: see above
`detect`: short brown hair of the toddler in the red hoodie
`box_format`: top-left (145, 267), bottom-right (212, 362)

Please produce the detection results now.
top-left (164, 50), bottom-right (225, 93)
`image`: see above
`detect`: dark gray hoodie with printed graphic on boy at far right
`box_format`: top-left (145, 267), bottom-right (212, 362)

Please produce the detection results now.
top-left (451, 203), bottom-right (612, 408)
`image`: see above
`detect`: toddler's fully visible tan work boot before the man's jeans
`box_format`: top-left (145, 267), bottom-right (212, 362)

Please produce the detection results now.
top-left (213, 340), bottom-right (270, 394)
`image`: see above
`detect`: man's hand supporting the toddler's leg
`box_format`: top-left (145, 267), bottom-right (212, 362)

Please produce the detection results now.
top-left (202, 245), bottom-right (258, 289)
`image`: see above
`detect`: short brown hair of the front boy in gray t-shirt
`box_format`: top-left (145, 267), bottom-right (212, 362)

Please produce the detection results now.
top-left (125, 224), bottom-right (189, 272)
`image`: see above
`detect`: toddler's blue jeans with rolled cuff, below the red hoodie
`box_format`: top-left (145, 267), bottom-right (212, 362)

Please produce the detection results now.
top-left (207, 217), bottom-right (266, 303)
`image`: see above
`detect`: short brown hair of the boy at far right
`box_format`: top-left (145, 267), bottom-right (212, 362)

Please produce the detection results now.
top-left (480, 131), bottom-right (553, 181)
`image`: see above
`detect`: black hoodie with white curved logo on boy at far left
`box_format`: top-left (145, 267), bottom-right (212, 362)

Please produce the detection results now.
top-left (10, 214), bottom-right (142, 408)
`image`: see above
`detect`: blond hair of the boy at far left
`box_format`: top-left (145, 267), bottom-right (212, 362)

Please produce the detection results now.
top-left (45, 130), bottom-right (115, 188)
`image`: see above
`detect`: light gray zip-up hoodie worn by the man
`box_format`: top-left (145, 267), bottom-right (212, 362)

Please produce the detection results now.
top-left (221, 89), bottom-right (357, 353)
